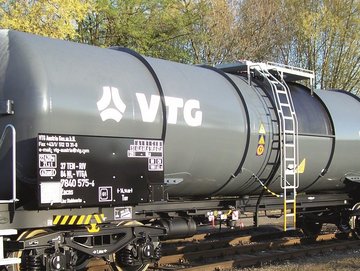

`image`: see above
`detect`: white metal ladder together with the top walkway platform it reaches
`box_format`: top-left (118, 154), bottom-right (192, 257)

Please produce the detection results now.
top-left (218, 60), bottom-right (315, 231)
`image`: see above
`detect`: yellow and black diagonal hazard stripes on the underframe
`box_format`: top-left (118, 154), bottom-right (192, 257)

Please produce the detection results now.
top-left (53, 214), bottom-right (105, 226)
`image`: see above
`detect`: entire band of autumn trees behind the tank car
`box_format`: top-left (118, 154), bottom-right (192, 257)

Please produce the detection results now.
top-left (0, 0), bottom-right (360, 94)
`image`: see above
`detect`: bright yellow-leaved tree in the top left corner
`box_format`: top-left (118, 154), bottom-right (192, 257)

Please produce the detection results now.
top-left (0, 0), bottom-right (91, 39)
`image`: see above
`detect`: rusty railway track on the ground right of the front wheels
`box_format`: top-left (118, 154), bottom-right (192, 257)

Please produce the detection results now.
top-left (150, 230), bottom-right (360, 271)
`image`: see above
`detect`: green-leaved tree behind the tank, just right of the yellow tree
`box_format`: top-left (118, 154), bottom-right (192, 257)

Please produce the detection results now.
top-left (78, 0), bottom-right (197, 62)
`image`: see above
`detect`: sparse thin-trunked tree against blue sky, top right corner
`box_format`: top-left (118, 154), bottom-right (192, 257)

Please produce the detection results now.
top-left (279, 0), bottom-right (360, 94)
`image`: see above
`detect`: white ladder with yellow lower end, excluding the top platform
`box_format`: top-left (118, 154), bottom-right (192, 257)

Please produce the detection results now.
top-left (258, 66), bottom-right (299, 231)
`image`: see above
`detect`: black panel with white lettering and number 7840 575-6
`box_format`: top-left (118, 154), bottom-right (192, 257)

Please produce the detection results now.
top-left (37, 134), bottom-right (164, 207)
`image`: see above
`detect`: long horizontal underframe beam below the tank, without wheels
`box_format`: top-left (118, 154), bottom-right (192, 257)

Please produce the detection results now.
top-left (0, 193), bottom-right (352, 229)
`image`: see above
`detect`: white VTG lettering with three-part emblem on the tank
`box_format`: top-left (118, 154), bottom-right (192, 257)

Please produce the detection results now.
top-left (97, 87), bottom-right (202, 127)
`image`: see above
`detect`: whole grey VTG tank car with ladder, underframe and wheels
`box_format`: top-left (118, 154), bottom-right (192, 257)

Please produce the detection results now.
top-left (0, 30), bottom-right (360, 270)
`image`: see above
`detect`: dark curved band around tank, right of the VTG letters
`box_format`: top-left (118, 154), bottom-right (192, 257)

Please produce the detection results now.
top-left (199, 65), bottom-right (250, 196)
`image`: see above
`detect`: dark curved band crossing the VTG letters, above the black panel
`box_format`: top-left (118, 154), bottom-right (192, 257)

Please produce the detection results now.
top-left (110, 46), bottom-right (167, 141)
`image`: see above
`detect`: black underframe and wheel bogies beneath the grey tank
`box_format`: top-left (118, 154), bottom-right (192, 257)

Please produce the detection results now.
top-left (0, 194), bottom-right (359, 270)
